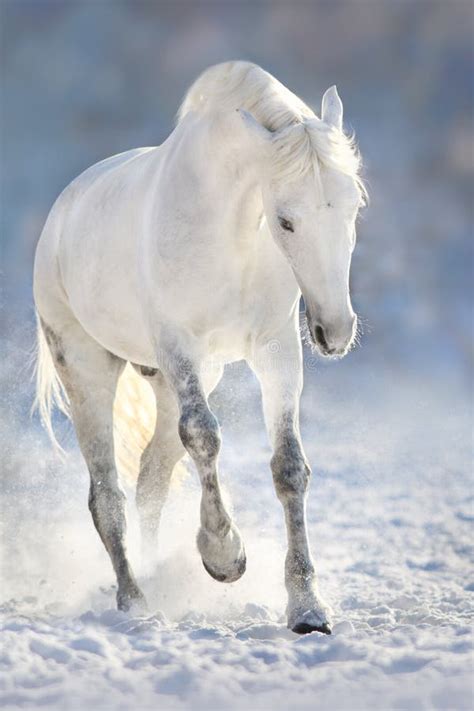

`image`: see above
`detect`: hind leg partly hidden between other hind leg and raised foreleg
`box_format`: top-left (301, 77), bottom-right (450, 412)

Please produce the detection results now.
top-left (136, 367), bottom-right (185, 559)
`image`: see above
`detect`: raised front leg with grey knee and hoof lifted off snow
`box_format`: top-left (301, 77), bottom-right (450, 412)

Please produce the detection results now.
top-left (163, 356), bottom-right (246, 583)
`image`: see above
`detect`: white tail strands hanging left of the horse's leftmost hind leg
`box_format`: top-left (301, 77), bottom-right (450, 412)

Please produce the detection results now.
top-left (32, 313), bottom-right (71, 455)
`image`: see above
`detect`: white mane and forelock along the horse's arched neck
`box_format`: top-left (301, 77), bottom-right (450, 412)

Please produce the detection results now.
top-left (178, 61), bottom-right (365, 195)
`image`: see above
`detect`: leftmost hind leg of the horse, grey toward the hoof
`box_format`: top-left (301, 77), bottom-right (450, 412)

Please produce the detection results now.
top-left (42, 319), bottom-right (146, 610)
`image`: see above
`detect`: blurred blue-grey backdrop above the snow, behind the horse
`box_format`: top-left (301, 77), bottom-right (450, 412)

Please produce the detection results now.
top-left (1, 0), bottom-right (474, 404)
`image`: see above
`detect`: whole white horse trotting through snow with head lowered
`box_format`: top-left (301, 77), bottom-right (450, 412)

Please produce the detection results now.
top-left (34, 62), bottom-right (364, 634)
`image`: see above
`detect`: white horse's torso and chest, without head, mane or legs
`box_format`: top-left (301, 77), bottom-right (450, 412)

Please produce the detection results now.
top-left (35, 116), bottom-right (298, 367)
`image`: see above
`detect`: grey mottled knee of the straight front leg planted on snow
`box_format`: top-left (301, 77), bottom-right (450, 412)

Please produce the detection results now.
top-left (270, 439), bottom-right (311, 500)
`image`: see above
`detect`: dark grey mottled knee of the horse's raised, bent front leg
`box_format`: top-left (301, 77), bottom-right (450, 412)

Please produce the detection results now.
top-left (179, 406), bottom-right (221, 463)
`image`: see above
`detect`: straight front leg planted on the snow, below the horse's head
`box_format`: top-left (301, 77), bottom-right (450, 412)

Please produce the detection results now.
top-left (252, 330), bottom-right (331, 634)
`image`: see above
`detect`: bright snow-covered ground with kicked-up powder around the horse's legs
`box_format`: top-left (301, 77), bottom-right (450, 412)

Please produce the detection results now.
top-left (0, 364), bottom-right (474, 711)
